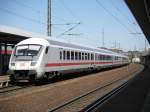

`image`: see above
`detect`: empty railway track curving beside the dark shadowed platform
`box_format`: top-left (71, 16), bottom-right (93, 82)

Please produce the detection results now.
top-left (48, 66), bottom-right (143, 112)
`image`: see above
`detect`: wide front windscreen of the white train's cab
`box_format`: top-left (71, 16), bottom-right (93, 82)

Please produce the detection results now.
top-left (15, 45), bottom-right (41, 56)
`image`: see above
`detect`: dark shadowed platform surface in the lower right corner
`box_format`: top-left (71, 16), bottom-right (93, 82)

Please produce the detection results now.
top-left (96, 67), bottom-right (150, 112)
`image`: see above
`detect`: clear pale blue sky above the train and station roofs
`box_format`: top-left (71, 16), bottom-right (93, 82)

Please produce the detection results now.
top-left (0, 0), bottom-right (149, 51)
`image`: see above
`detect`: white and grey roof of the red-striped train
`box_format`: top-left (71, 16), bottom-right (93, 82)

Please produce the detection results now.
top-left (17, 37), bottom-right (126, 57)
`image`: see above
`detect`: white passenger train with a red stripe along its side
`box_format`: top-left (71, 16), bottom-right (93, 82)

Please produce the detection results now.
top-left (9, 38), bottom-right (129, 81)
